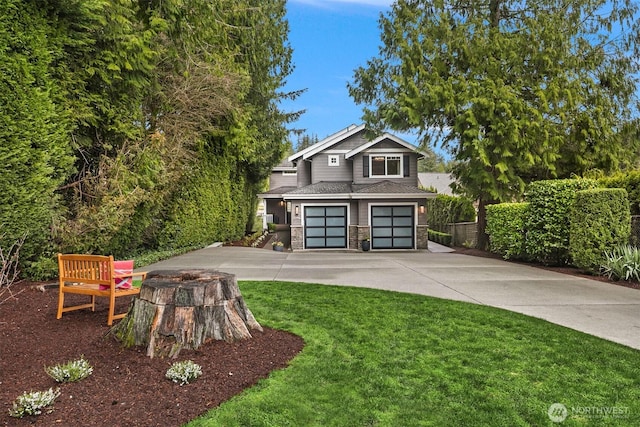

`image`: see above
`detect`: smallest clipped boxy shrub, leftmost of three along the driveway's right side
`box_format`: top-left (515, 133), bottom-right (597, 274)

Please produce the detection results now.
top-left (486, 203), bottom-right (529, 259)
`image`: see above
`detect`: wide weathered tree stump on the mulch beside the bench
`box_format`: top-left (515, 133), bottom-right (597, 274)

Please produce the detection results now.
top-left (109, 269), bottom-right (262, 358)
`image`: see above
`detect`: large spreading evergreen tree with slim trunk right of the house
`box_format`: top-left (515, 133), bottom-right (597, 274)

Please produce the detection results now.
top-left (349, 0), bottom-right (640, 247)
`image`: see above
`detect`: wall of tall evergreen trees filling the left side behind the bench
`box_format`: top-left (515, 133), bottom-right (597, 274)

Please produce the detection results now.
top-left (0, 0), bottom-right (298, 278)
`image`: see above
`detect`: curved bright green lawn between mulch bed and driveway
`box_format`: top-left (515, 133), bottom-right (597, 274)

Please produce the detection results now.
top-left (188, 282), bottom-right (640, 427)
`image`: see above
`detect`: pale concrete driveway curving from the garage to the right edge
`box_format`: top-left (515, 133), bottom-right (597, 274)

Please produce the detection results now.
top-left (144, 247), bottom-right (640, 349)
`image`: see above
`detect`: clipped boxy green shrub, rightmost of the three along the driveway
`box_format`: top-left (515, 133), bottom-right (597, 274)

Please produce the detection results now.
top-left (569, 188), bottom-right (631, 273)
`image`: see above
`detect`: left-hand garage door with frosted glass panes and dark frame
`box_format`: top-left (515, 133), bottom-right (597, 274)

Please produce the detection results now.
top-left (304, 206), bottom-right (347, 249)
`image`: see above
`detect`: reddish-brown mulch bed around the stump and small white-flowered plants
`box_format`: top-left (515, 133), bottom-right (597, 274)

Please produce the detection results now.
top-left (0, 283), bottom-right (304, 427)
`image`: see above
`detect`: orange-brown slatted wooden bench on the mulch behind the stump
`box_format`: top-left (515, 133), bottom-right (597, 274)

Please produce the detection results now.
top-left (57, 254), bottom-right (147, 326)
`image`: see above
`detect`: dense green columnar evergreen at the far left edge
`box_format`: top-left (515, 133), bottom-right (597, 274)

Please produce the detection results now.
top-left (0, 0), bottom-right (73, 267)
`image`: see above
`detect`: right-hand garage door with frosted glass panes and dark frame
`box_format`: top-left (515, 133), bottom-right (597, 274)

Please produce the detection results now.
top-left (371, 206), bottom-right (414, 249)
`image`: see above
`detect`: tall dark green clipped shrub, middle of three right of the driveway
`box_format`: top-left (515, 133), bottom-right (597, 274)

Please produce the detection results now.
top-left (524, 179), bottom-right (596, 265)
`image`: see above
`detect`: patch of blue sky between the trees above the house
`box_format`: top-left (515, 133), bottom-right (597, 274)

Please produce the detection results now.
top-left (283, 0), bottom-right (392, 144)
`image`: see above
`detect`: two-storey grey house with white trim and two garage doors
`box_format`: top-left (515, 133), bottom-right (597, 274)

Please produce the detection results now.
top-left (258, 125), bottom-right (435, 250)
